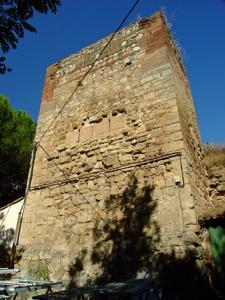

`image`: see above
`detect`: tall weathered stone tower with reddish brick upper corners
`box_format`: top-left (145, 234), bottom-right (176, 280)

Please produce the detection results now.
top-left (20, 13), bottom-right (207, 284)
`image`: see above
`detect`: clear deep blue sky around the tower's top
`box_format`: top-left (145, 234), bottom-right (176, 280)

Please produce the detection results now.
top-left (0, 0), bottom-right (225, 143)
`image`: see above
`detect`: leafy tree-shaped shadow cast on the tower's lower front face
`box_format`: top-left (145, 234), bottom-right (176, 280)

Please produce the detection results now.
top-left (69, 175), bottom-right (160, 287)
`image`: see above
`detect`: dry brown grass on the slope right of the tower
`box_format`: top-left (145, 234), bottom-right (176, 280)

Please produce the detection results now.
top-left (204, 144), bottom-right (225, 168)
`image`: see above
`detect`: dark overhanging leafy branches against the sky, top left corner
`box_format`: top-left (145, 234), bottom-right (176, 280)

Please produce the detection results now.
top-left (0, 0), bottom-right (61, 74)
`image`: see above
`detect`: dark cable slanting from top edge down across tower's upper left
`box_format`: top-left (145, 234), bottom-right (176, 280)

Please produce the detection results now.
top-left (37, 0), bottom-right (140, 144)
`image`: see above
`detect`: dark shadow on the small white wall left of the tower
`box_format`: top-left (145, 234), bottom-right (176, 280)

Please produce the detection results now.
top-left (0, 213), bottom-right (23, 268)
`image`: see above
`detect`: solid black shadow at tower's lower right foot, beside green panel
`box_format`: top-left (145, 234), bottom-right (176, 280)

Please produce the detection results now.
top-left (156, 252), bottom-right (217, 300)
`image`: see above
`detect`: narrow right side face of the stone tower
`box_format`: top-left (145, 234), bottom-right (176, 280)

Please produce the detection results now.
top-left (166, 44), bottom-right (209, 250)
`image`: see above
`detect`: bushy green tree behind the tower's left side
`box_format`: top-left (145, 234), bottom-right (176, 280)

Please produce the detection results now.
top-left (0, 95), bottom-right (35, 205)
